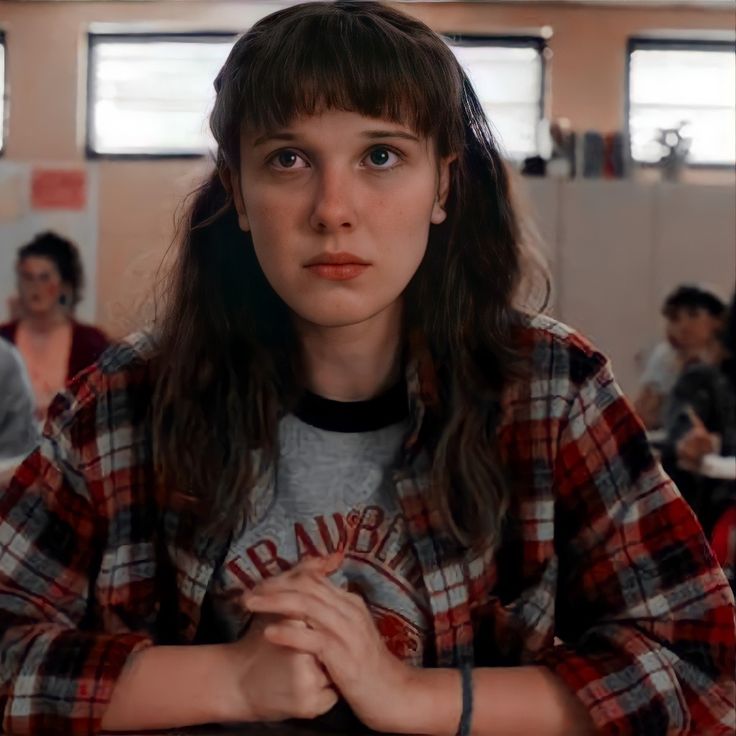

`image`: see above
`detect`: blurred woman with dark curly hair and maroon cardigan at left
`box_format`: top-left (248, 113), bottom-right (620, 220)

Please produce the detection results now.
top-left (0, 232), bottom-right (109, 420)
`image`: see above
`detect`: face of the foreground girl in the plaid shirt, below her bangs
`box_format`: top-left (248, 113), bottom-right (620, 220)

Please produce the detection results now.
top-left (233, 110), bottom-right (451, 334)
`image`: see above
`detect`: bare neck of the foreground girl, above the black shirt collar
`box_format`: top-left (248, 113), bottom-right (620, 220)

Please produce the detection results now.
top-left (296, 305), bottom-right (402, 401)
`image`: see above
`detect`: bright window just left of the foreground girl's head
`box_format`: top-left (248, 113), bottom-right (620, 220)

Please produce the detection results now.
top-left (87, 33), bottom-right (235, 156)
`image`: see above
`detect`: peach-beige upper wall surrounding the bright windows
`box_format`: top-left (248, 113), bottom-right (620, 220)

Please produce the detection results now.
top-left (0, 1), bottom-right (734, 334)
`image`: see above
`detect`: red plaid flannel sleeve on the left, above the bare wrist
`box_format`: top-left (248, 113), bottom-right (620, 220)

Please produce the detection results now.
top-left (0, 380), bottom-right (150, 736)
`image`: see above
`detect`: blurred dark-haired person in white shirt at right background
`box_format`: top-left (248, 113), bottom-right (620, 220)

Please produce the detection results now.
top-left (634, 284), bottom-right (726, 430)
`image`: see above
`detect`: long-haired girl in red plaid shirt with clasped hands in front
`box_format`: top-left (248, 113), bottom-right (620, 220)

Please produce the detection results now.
top-left (0, 2), bottom-right (736, 736)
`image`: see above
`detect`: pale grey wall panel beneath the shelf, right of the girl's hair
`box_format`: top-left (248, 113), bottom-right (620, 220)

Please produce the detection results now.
top-left (521, 179), bottom-right (736, 394)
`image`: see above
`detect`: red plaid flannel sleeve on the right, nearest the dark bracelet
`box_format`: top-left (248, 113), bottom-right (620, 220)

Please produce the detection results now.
top-left (539, 354), bottom-right (736, 736)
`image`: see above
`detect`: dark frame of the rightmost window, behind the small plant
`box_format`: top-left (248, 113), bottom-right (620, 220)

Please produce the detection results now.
top-left (624, 36), bottom-right (736, 171)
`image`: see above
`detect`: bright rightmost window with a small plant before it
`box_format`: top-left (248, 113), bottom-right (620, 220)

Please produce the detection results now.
top-left (627, 39), bottom-right (736, 166)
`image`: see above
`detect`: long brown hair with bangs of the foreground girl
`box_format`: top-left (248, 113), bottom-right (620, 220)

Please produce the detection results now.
top-left (153, 2), bottom-right (548, 545)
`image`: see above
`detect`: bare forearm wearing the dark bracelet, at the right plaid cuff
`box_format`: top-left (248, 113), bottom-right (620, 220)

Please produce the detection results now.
top-left (401, 666), bottom-right (594, 736)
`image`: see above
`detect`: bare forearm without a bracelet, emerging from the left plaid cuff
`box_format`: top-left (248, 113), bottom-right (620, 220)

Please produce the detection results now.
top-left (102, 645), bottom-right (246, 731)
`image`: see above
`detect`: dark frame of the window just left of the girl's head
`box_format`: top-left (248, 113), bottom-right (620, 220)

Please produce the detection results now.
top-left (84, 31), bottom-right (240, 161)
